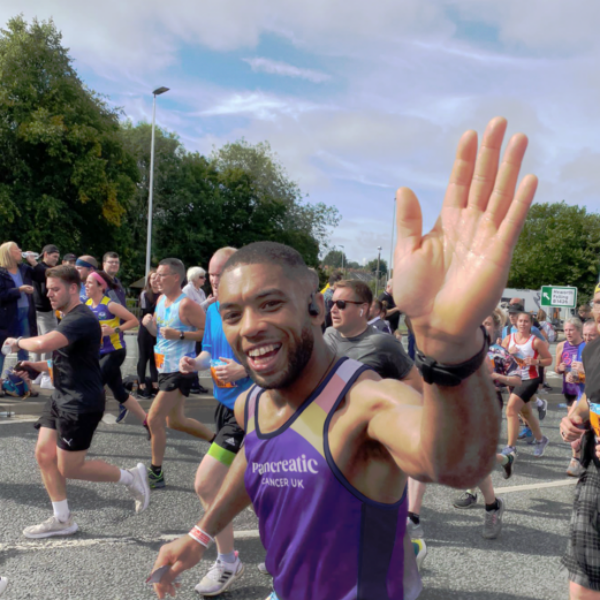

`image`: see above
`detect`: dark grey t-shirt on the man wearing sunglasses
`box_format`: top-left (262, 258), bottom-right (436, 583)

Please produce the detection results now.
top-left (325, 326), bottom-right (413, 379)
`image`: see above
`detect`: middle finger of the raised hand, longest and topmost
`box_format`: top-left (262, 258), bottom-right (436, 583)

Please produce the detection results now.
top-left (468, 117), bottom-right (506, 211)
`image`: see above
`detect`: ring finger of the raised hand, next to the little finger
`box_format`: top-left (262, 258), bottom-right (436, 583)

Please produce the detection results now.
top-left (486, 133), bottom-right (527, 228)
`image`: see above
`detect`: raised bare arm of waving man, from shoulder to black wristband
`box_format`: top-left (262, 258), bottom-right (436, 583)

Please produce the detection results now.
top-left (364, 332), bottom-right (500, 487)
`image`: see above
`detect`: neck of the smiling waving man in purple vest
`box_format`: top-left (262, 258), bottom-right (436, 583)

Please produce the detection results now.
top-left (268, 333), bottom-right (335, 409)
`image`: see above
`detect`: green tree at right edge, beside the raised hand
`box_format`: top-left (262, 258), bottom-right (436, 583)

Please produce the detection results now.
top-left (508, 201), bottom-right (600, 298)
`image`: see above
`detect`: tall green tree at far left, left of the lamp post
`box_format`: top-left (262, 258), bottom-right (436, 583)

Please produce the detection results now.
top-left (0, 17), bottom-right (138, 255)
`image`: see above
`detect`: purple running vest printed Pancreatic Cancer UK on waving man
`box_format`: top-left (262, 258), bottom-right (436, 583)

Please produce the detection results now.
top-left (244, 358), bottom-right (421, 600)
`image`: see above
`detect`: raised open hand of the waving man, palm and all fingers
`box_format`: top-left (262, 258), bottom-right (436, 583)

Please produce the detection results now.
top-left (393, 117), bottom-right (537, 352)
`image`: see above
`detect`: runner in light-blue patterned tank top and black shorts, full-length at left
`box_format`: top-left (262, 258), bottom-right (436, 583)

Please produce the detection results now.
top-left (143, 258), bottom-right (214, 488)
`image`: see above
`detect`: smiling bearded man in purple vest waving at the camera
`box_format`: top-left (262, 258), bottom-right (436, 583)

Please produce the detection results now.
top-left (154, 119), bottom-right (536, 600)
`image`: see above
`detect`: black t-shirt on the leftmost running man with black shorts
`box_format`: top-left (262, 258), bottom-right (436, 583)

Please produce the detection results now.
top-left (52, 304), bottom-right (104, 413)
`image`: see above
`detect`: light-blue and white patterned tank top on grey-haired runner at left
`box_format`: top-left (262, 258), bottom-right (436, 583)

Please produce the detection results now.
top-left (154, 292), bottom-right (196, 373)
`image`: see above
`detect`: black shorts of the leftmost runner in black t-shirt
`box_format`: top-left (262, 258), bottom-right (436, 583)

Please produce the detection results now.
top-left (34, 398), bottom-right (104, 452)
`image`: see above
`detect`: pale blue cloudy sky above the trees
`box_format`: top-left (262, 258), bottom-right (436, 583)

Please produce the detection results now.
top-left (0, 0), bottom-right (600, 262)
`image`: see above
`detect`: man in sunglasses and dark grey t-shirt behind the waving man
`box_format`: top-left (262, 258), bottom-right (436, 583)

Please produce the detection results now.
top-left (325, 279), bottom-right (421, 391)
